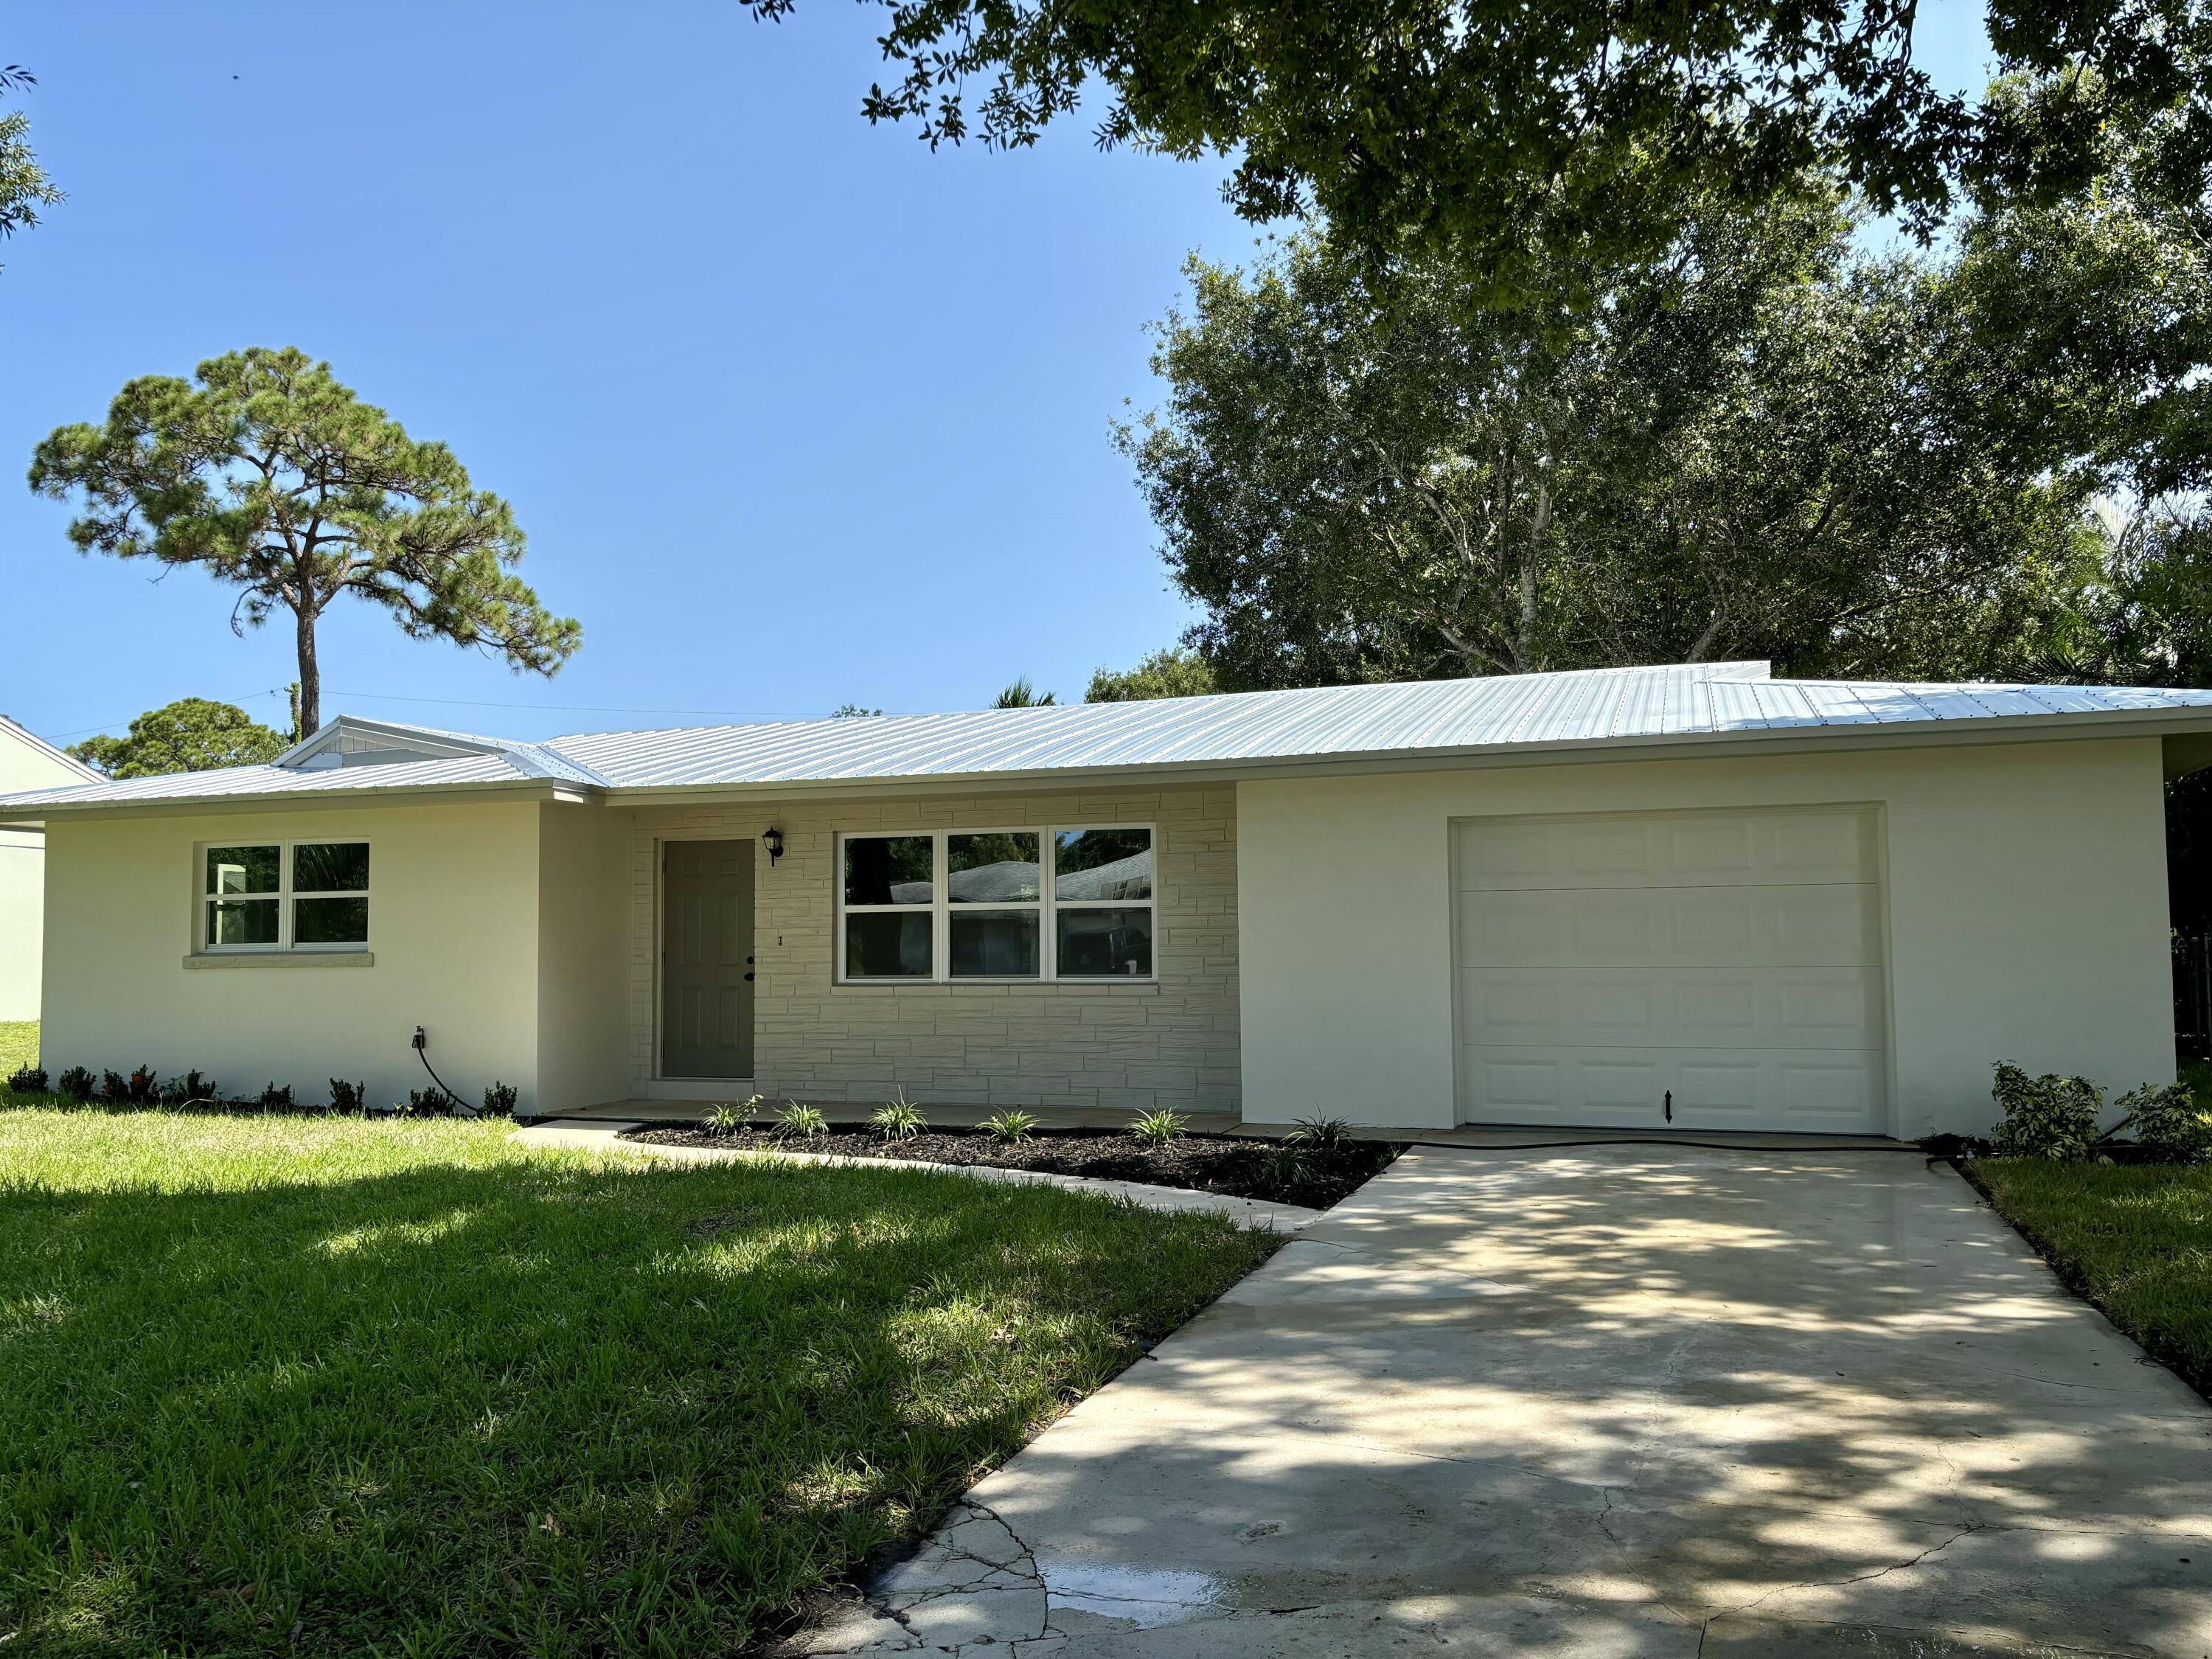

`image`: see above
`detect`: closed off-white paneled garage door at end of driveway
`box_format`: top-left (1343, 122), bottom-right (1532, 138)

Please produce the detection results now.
top-left (1453, 810), bottom-right (1889, 1135)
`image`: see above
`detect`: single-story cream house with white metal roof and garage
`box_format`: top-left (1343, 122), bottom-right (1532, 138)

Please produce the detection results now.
top-left (0, 664), bottom-right (2212, 1135)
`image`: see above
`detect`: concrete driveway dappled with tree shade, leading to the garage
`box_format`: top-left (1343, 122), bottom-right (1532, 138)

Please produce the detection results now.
top-left (799, 1148), bottom-right (2212, 1659)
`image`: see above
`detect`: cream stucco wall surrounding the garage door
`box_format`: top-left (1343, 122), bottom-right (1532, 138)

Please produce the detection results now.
top-left (1237, 737), bottom-right (2174, 1137)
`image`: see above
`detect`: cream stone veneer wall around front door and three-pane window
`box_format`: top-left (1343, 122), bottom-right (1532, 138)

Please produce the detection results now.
top-left (630, 785), bottom-right (1241, 1113)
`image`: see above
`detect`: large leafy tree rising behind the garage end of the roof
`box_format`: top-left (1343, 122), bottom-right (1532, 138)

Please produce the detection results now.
top-left (1121, 188), bottom-right (2108, 690)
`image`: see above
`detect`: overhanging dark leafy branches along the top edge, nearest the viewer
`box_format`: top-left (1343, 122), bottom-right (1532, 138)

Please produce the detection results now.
top-left (745, 0), bottom-right (2212, 296)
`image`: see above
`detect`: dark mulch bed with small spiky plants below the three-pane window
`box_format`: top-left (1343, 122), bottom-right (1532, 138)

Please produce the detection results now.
top-left (624, 1124), bottom-right (1398, 1210)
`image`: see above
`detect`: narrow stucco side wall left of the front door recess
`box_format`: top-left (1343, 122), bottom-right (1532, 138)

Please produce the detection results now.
top-left (538, 801), bottom-right (633, 1113)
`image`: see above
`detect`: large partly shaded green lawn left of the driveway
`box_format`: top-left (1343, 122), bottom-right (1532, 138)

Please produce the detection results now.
top-left (0, 1106), bottom-right (1274, 1657)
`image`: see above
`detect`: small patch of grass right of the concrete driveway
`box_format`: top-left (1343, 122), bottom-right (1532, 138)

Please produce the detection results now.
top-left (1969, 1159), bottom-right (2212, 1391)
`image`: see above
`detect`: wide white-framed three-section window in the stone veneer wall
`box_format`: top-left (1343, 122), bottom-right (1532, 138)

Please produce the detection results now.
top-left (838, 825), bottom-right (1152, 984)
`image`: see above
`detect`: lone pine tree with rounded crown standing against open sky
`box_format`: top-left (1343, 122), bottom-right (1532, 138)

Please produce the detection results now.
top-left (31, 347), bottom-right (582, 734)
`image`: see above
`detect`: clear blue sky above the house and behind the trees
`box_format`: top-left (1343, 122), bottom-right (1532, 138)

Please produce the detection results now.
top-left (0, 0), bottom-right (1980, 741)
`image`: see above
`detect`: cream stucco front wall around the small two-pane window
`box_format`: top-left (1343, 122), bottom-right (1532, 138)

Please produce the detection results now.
top-left (42, 801), bottom-right (540, 1110)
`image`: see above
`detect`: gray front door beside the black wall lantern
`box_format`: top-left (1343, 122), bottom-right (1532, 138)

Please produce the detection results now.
top-left (661, 841), bottom-right (752, 1077)
